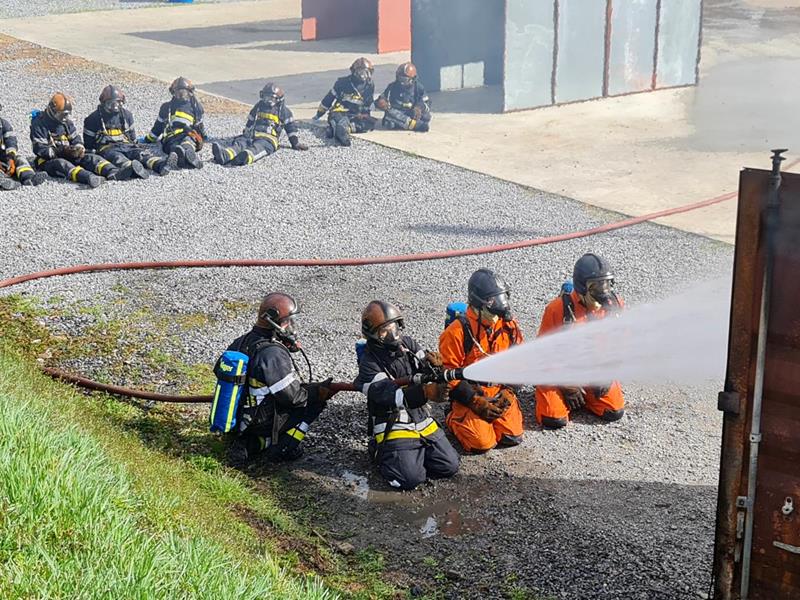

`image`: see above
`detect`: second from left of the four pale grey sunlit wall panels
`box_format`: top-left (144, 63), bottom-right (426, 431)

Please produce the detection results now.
top-left (555, 0), bottom-right (606, 102)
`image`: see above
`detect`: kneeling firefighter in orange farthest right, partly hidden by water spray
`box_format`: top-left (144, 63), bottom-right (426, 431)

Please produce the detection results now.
top-left (536, 254), bottom-right (625, 429)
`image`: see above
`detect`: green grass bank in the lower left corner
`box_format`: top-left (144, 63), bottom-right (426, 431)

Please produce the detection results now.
top-left (0, 296), bottom-right (400, 599)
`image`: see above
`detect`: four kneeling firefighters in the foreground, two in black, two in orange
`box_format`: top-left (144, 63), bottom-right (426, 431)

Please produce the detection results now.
top-left (229, 254), bottom-right (624, 490)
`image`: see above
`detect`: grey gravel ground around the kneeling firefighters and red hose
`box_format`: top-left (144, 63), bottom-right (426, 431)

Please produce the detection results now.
top-left (0, 38), bottom-right (733, 598)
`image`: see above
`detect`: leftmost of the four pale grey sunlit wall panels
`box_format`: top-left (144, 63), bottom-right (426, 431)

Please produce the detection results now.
top-left (503, 0), bottom-right (555, 110)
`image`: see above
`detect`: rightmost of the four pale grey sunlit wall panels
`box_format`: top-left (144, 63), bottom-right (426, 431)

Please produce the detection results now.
top-left (656, 0), bottom-right (702, 87)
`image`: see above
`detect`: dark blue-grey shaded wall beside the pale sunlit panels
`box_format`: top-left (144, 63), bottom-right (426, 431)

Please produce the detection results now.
top-left (411, 0), bottom-right (505, 91)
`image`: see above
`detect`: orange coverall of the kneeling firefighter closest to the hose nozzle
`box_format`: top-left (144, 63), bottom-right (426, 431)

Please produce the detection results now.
top-left (439, 307), bottom-right (522, 452)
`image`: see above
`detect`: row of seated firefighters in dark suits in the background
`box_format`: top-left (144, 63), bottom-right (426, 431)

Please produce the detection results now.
top-left (0, 58), bottom-right (431, 190)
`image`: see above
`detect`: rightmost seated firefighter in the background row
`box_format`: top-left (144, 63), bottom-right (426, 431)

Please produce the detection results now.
top-left (375, 62), bottom-right (431, 132)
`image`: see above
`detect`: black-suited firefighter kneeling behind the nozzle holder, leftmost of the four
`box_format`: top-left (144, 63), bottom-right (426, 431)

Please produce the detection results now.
top-left (228, 292), bottom-right (332, 467)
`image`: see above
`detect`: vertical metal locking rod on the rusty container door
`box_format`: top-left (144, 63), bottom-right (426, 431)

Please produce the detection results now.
top-left (739, 150), bottom-right (786, 600)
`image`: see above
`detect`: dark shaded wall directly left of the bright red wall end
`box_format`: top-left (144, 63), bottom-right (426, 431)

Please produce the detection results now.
top-left (301, 0), bottom-right (378, 40)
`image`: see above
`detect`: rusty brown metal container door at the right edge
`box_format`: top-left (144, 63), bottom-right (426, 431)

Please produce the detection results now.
top-left (714, 162), bottom-right (800, 600)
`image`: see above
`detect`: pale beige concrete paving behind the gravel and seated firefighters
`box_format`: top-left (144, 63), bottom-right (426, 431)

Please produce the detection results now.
top-left (2, 0), bottom-right (800, 243)
